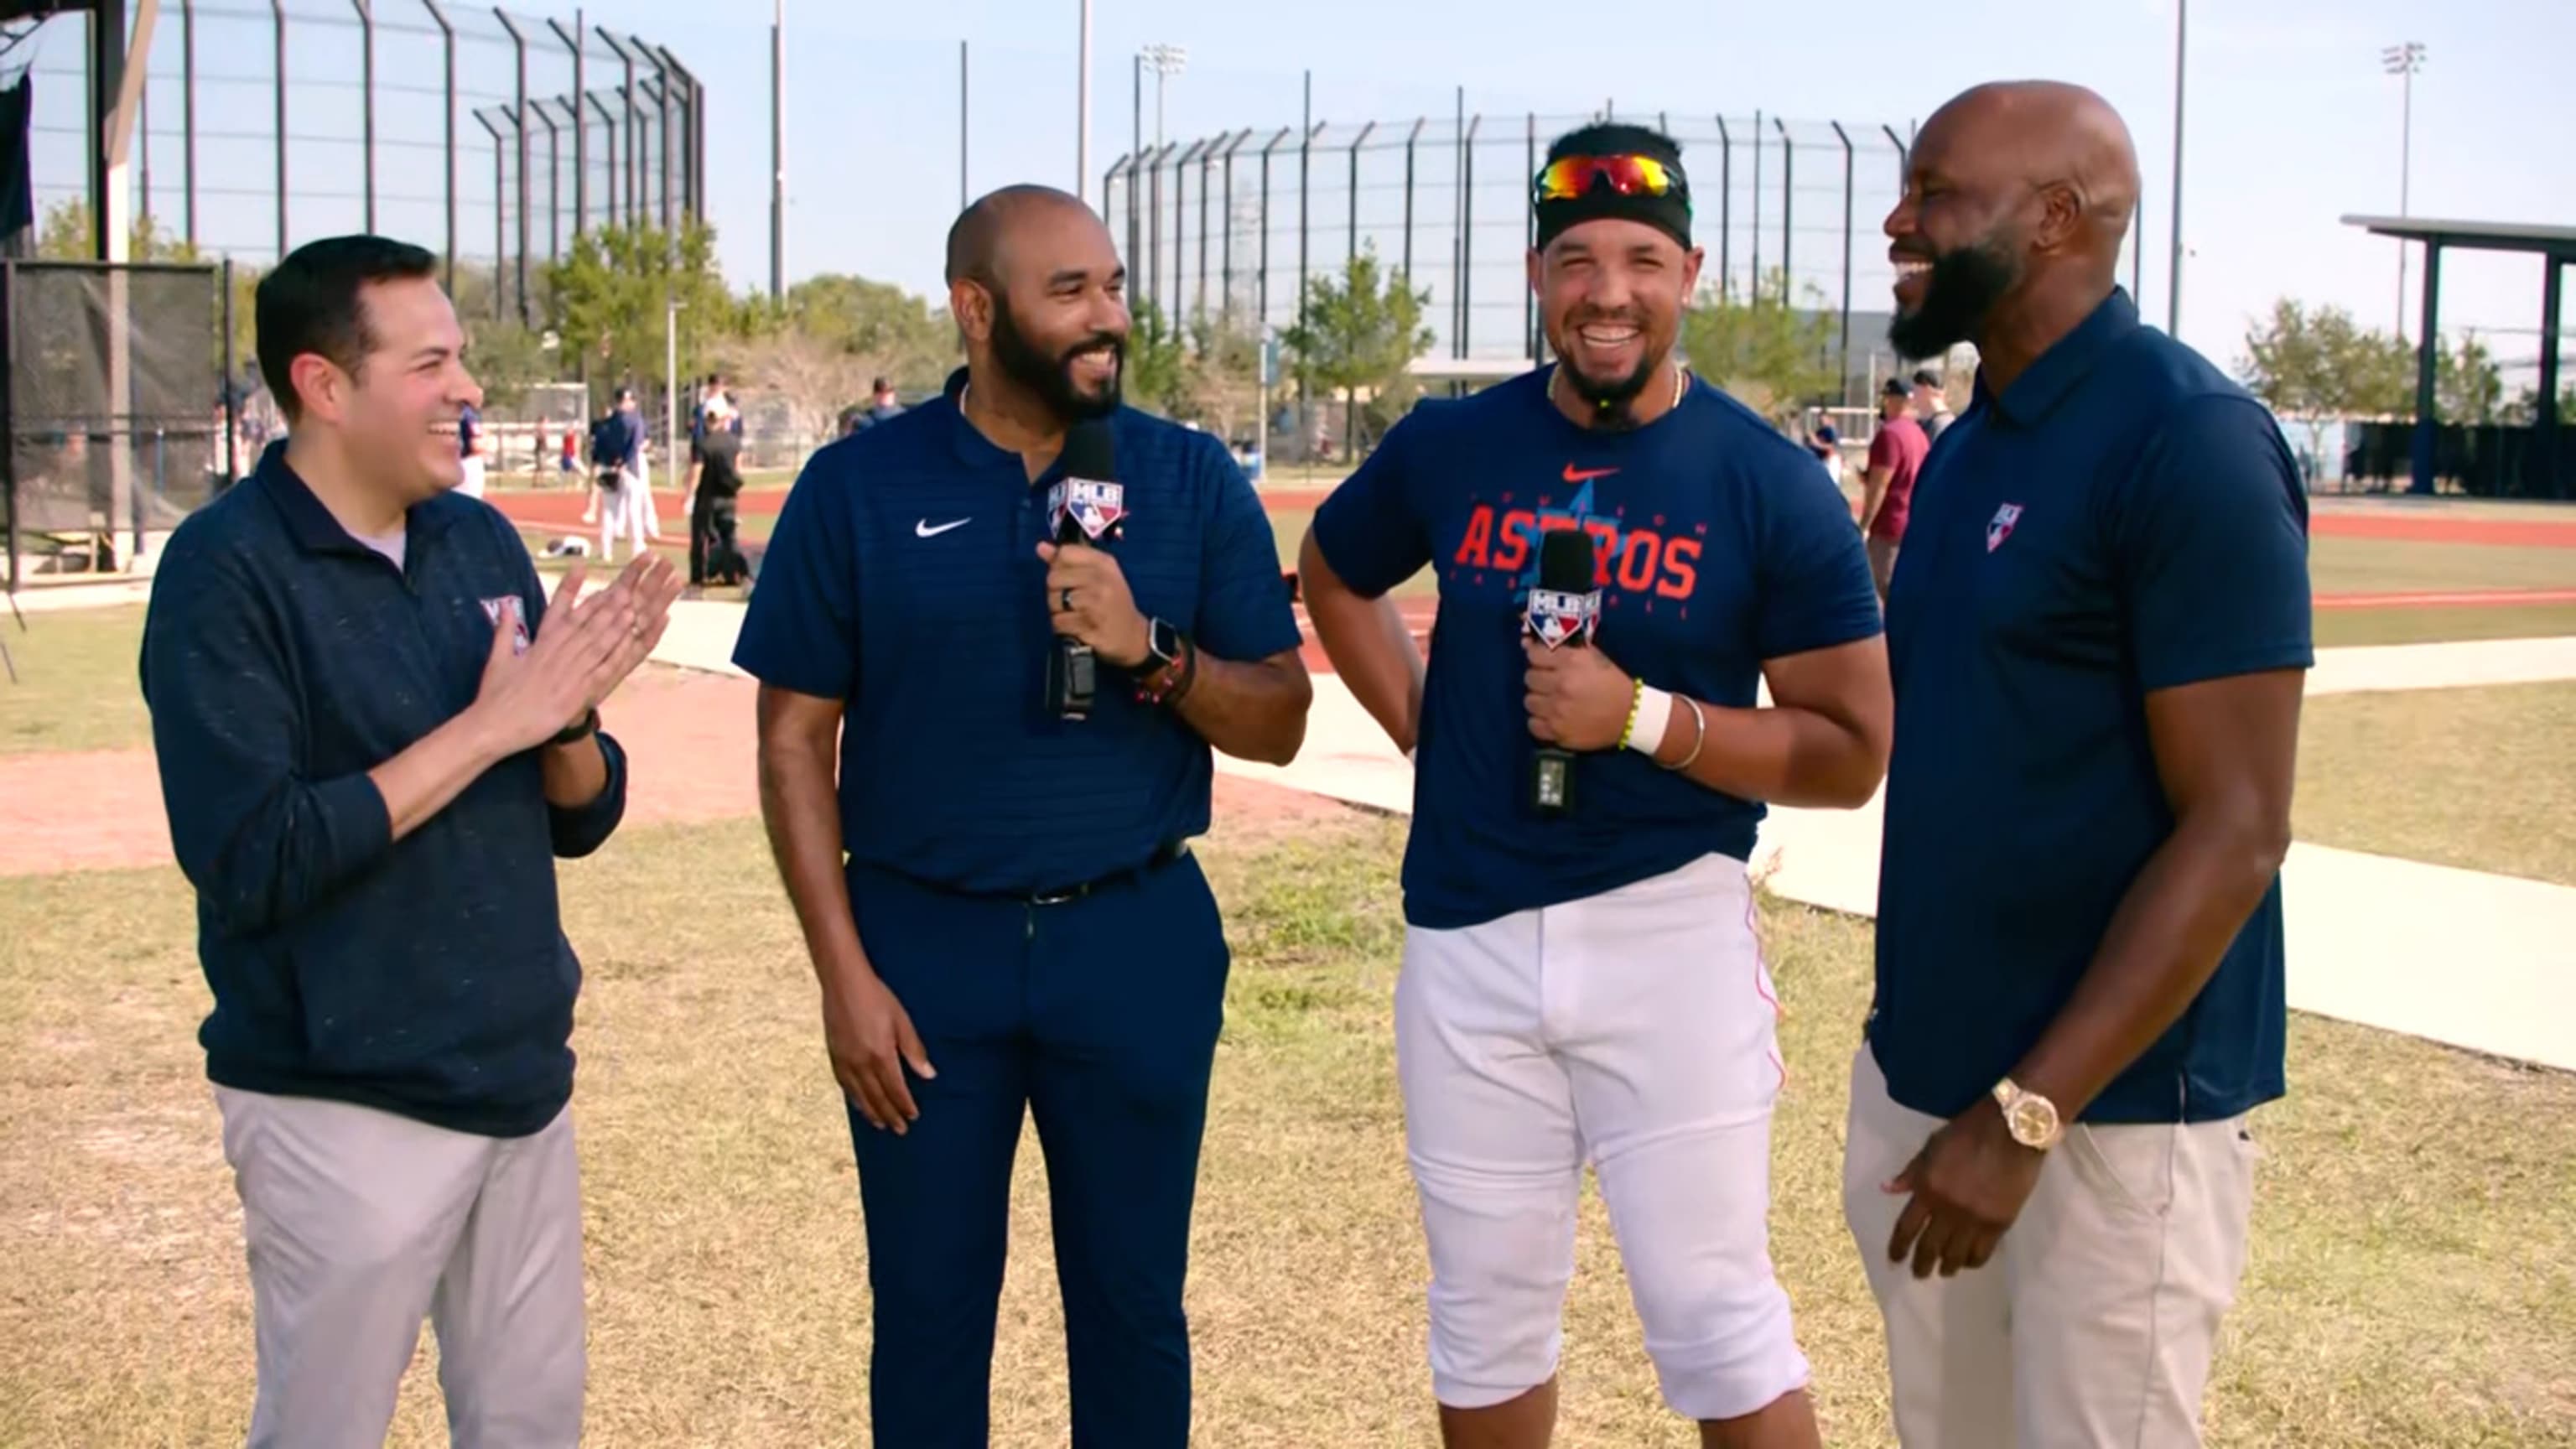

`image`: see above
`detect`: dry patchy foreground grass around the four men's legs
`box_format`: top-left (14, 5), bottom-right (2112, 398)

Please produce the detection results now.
top-left (0, 809), bottom-right (2576, 1449)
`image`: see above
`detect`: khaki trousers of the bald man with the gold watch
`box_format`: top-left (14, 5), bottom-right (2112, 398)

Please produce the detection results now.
top-left (1841, 1044), bottom-right (2257, 1449)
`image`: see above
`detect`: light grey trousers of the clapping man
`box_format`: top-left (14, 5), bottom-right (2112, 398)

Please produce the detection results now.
top-left (214, 1085), bottom-right (587, 1449)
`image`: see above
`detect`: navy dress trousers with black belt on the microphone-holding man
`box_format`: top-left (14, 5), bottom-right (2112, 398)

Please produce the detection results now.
top-left (848, 854), bottom-right (1231, 1449)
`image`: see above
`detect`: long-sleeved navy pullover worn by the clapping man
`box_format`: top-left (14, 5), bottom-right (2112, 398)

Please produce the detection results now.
top-left (142, 441), bottom-right (626, 1137)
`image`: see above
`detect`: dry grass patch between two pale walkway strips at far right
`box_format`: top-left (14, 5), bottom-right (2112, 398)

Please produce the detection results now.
top-left (2290, 681), bottom-right (2576, 885)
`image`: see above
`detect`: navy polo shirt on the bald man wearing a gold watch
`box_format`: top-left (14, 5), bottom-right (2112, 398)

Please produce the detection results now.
top-left (1867, 291), bottom-right (2314, 1122)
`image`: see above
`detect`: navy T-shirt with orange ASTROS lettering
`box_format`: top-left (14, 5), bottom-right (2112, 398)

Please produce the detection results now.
top-left (1314, 369), bottom-right (1881, 931)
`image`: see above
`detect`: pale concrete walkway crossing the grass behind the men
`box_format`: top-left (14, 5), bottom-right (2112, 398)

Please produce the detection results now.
top-left (654, 603), bottom-right (2576, 1070)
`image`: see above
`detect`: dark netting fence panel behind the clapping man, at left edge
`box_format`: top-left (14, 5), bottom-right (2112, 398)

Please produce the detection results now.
top-left (5, 261), bottom-right (226, 574)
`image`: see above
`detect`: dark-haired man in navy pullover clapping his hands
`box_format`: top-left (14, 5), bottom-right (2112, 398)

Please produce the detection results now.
top-left (142, 237), bottom-right (680, 1446)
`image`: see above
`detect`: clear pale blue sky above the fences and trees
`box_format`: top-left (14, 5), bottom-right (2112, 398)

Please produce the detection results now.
top-left (20, 0), bottom-right (2576, 384)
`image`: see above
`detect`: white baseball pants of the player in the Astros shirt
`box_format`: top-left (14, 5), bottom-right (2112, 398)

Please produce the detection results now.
top-left (1396, 856), bottom-right (1809, 1420)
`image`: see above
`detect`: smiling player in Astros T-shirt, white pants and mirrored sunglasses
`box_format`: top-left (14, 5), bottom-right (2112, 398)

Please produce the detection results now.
top-left (1298, 127), bottom-right (1891, 1446)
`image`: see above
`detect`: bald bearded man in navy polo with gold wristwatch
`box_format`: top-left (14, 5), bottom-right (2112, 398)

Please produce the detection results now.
top-left (1845, 82), bottom-right (2314, 1449)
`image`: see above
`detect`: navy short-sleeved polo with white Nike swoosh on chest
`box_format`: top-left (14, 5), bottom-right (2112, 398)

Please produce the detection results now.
top-left (735, 384), bottom-right (1298, 895)
